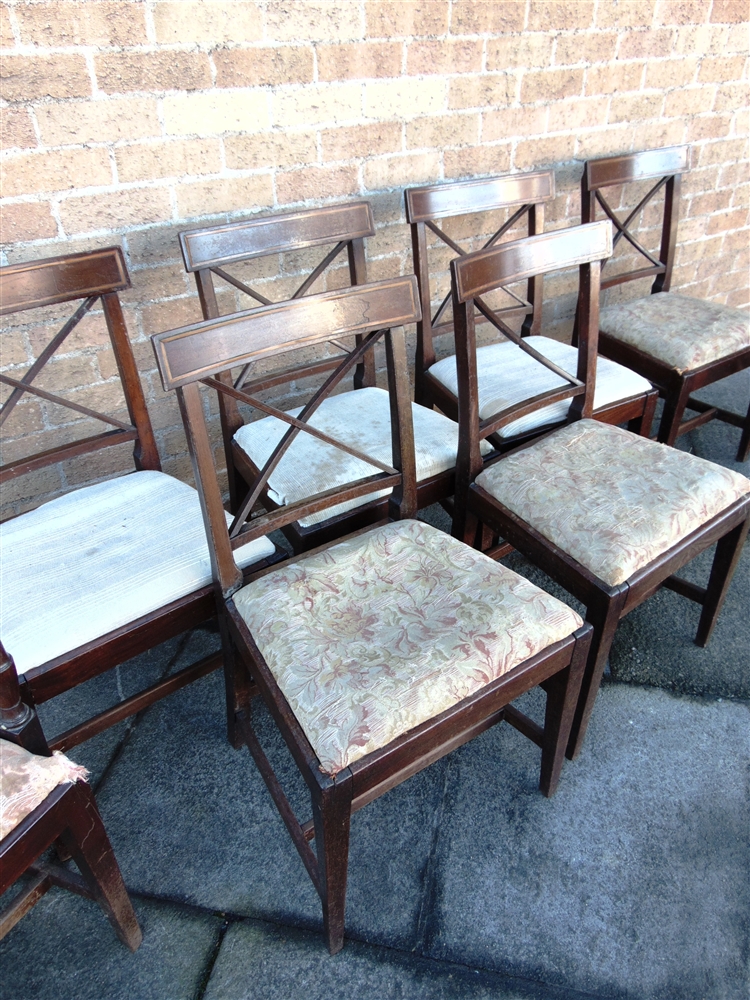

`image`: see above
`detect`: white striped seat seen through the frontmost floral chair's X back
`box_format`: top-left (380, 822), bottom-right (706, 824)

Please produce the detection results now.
top-left (234, 387), bottom-right (491, 527)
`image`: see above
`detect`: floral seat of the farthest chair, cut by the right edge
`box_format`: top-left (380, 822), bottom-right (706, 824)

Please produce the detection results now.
top-left (599, 292), bottom-right (750, 374)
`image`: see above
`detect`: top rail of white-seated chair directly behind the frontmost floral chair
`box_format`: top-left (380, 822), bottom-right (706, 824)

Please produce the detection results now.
top-left (180, 201), bottom-right (375, 272)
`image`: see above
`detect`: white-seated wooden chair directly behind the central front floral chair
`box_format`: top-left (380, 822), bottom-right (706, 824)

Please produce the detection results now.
top-left (180, 201), bottom-right (470, 552)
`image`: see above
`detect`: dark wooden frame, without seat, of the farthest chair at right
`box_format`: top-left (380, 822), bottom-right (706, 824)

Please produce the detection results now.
top-left (581, 146), bottom-right (750, 462)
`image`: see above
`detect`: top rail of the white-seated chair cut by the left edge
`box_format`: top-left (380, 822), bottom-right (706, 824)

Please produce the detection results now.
top-left (0, 247), bottom-right (130, 316)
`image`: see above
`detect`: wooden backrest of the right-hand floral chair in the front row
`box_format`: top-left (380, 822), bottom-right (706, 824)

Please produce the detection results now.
top-left (451, 220), bottom-right (612, 491)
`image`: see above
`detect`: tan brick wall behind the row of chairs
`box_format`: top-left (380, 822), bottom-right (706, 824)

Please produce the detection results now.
top-left (0, 0), bottom-right (750, 509)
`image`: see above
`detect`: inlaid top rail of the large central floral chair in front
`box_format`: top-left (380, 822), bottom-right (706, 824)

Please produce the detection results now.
top-left (151, 275), bottom-right (422, 390)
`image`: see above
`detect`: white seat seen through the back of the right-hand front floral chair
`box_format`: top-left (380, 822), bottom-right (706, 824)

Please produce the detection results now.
top-left (430, 337), bottom-right (651, 438)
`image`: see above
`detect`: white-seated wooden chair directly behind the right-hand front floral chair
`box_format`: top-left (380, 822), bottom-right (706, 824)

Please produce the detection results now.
top-left (405, 170), bottom-right (658, 451)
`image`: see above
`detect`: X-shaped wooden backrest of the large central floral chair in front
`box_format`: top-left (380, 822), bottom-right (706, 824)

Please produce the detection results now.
top-left (152, 275), bottom-right (420, 596)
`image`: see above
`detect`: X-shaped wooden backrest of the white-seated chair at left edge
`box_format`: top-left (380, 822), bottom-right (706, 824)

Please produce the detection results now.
top-left (0, 247), bottom-right (160, 520)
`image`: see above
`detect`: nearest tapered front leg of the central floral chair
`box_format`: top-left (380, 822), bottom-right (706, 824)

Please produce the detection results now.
top-left (313, 775), bottom-right (352, 955)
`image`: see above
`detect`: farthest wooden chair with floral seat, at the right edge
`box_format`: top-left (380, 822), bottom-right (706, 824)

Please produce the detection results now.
top-left (581, 146), bottom-right (750, 462)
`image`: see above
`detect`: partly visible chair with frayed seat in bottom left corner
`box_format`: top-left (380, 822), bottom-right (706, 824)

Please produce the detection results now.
top-left (0, 646), bottom-right (141, 951)
